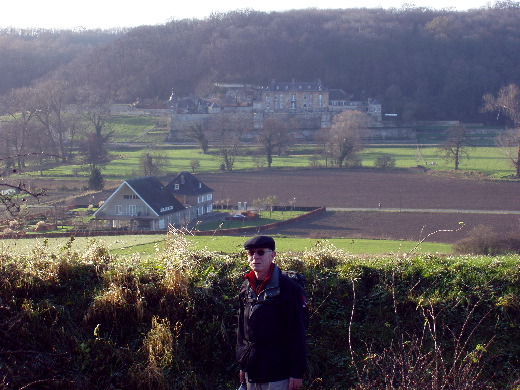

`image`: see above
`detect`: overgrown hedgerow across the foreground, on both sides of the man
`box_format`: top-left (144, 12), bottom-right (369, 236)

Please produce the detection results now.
top-left (0, 232), bottom-right (520, 390)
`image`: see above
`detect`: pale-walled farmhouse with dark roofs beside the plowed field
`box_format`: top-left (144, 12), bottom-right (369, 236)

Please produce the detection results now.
top-left (94, 172), bottom-right (213, 230)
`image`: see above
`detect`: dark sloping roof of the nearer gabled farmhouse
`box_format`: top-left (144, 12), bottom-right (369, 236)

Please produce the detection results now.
top-left (125, 176), bottom-right (186, 215)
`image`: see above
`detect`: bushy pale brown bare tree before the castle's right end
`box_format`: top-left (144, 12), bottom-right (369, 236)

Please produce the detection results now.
top-left (325, 111), bottom-right (370, 167)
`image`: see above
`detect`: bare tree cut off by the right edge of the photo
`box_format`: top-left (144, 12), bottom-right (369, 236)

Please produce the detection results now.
top-left (482, 84), bottom-right (520, 177)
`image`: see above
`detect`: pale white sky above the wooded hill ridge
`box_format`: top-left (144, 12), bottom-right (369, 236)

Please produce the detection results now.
top-left (0, 0), bottom-right (494, 29)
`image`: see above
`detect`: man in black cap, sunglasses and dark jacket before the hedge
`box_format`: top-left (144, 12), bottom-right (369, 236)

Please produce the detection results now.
top-left (237, 236), bottom-right (307, 390)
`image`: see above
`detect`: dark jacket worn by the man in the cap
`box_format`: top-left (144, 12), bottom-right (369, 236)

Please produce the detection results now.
top-left (237, 265), bottom-right (307, 382)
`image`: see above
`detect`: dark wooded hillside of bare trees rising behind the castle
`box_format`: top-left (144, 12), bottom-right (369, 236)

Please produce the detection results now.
top-left (0, 2), bottom-right (520, 122)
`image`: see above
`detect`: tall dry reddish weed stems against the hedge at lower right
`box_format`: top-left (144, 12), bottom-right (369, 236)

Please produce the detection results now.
top-left (349, 277), bottom-right (494, 390)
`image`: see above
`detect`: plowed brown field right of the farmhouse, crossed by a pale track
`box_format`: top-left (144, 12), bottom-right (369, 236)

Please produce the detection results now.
top-left (198, 169), bottom-right (520, 243)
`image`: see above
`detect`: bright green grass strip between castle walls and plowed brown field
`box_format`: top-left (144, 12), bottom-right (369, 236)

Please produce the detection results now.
top-left (26, 146), bottom-right (514, 180)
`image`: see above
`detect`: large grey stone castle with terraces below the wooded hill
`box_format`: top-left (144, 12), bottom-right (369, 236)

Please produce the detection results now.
top-left (168, 80), bottom-right (382, 141)
